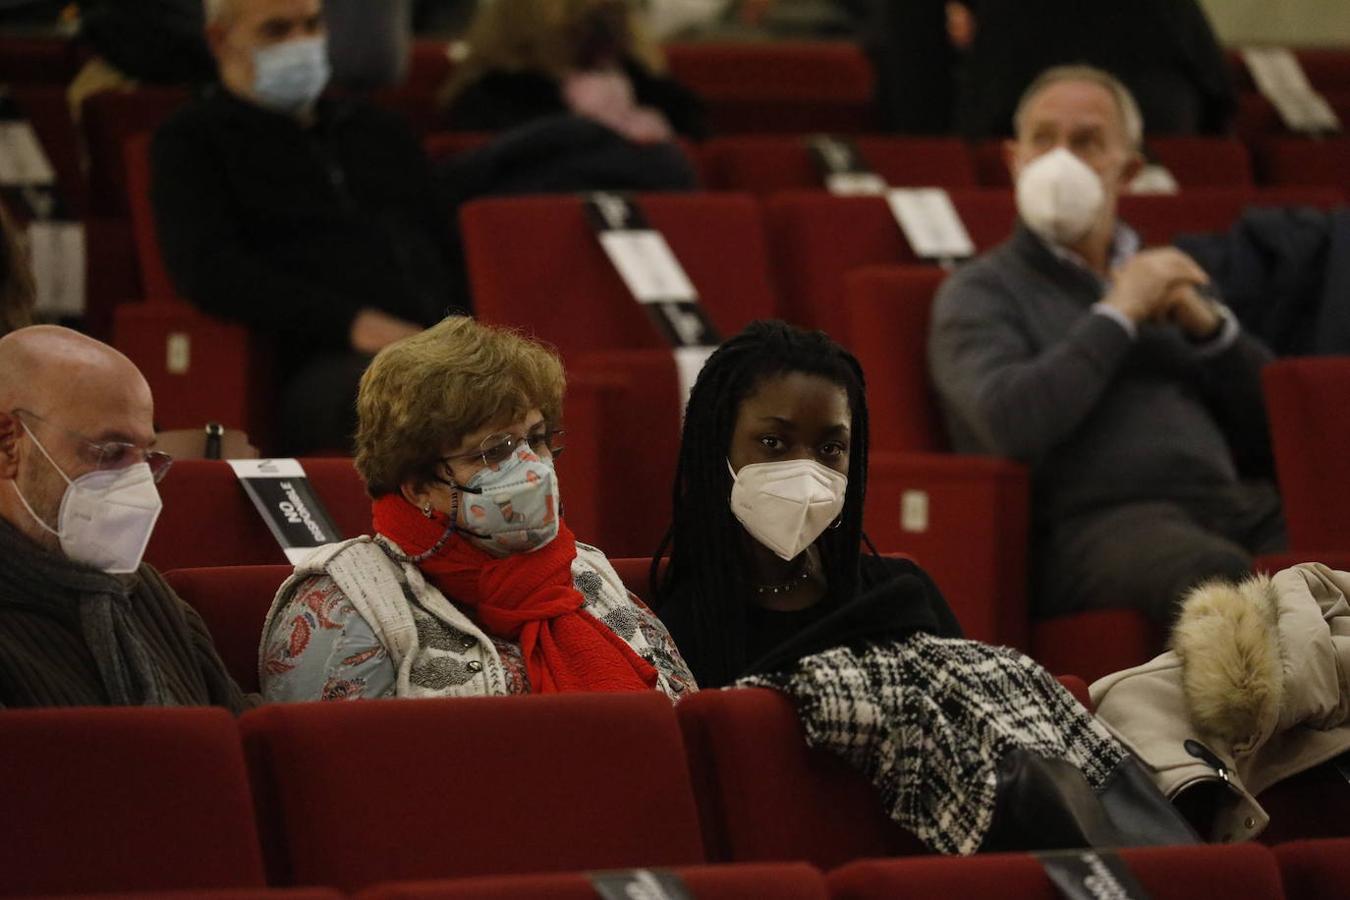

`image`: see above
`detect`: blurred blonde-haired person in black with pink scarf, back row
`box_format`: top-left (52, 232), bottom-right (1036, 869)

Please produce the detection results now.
top-left (441, 0), bottom-right (706, 143)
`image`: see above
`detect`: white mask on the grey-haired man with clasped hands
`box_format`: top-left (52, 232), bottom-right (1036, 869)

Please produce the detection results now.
top-left (1017, 147), bottom-right (1106, 247)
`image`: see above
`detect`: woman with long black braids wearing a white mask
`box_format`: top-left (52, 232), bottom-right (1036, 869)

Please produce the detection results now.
top-left (653, 321), bottom-right (961, 687)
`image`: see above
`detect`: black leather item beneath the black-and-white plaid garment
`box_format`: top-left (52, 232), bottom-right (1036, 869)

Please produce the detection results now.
top-left (980, 749), bottom-right (1203, 853)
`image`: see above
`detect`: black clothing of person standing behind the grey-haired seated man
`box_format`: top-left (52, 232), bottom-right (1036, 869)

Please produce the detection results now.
top-left (956, 0), bottom-right (1237, 139)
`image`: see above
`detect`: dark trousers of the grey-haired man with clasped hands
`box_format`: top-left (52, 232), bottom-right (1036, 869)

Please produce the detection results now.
top-left (1033, 482), bottom-right (1287, 625)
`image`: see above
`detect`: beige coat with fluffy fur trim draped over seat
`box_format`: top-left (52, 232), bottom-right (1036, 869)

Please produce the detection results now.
top-left (1091, 563), bottom-right (1350, 842)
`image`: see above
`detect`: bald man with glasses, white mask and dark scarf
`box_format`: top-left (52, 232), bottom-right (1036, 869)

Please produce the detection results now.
top-left (0, 325), bottom-right (246, 712)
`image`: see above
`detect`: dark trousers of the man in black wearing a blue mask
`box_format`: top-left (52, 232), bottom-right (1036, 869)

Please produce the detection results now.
top-left (277, 352), bottom-right (370, 456)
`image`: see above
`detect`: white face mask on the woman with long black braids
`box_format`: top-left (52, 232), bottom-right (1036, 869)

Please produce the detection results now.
top-left (726, 459), bottom-right (848, 560)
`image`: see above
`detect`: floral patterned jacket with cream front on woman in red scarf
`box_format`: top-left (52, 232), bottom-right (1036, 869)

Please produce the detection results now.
top-left (258, 536), bottom-right (697, 703)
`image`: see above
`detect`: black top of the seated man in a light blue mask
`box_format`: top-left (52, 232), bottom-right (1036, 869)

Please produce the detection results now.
top-left (151, 88), bottom-right (463, 364)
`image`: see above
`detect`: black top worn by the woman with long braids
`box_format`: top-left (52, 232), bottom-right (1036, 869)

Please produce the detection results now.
top-left (656, 555), bottom-right (961, 688)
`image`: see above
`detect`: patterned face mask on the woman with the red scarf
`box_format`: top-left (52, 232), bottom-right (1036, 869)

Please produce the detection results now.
top-left (456, 441), bottom-right (559, 556)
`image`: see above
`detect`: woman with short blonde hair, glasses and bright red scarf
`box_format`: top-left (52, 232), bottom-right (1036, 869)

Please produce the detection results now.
top-left (259, 317), bottom-right (694, 700)
